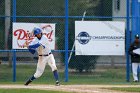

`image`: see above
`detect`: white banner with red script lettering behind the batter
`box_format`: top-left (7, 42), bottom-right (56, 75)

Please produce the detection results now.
top-left (12, 22), bottom-right (55, 49)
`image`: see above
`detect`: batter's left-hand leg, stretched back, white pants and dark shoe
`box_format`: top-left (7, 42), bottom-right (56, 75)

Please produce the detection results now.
top-left (24, 57), bottom-right (46, 85)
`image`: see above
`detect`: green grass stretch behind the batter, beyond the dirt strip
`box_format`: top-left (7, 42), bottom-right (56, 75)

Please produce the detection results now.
top-left (0, 65), bottom-right (140, 85)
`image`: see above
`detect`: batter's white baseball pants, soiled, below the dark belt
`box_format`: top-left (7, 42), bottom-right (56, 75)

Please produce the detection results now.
top-left (34, 54), bottom-right (57, 78)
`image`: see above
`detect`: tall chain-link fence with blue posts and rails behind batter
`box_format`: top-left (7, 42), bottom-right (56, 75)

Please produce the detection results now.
top-left (0, 0), bottom-right (140, 82)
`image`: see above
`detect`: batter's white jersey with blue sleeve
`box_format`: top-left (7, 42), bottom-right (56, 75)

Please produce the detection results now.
top-left (29, 35), bottom-right (51, 55)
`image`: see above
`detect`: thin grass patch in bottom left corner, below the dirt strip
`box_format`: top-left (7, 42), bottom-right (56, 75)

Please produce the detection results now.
top-left (0, 89), bottom-right (70, 93)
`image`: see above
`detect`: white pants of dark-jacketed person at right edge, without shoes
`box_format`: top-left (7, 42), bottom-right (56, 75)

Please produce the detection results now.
top-left (132, 63), bottom-right (140, 80)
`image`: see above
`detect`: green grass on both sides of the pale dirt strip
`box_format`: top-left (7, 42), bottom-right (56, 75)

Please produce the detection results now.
top-left (0, 65), bottom-right (140, 93)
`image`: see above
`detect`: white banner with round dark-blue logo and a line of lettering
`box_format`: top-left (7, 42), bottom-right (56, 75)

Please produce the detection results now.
top-left (75, 21), bottom-right (125, 55)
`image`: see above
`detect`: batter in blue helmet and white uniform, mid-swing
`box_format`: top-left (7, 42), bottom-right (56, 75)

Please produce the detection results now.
top-left (23, 28), bottom-right (60, 86)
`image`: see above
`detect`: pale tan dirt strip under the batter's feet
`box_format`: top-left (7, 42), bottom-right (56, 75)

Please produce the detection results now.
top-left (0, 84), bottom-right (140, 93)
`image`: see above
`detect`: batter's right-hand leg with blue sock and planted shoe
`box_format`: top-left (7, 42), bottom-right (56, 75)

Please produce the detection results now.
top-left (48, 54), bottom-right (60, 86)
